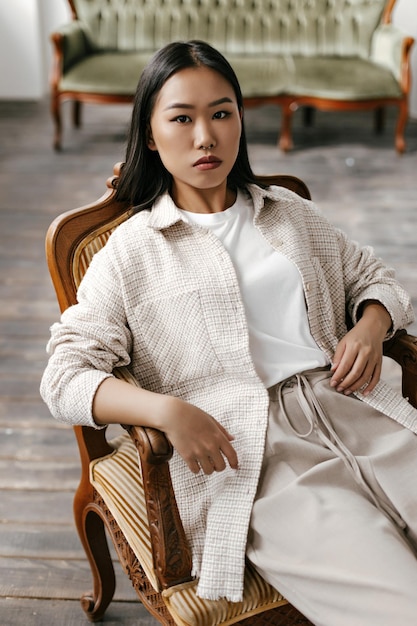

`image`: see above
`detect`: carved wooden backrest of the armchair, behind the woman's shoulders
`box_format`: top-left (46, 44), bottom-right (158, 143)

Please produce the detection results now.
top-left (46, 163), bottom-right (310, 311)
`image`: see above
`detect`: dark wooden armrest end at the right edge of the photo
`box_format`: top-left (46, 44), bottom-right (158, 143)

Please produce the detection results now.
top-left (384, 330), bottom-right (417, 408)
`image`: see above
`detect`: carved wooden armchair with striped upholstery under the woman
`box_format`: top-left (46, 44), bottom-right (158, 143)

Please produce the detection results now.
top-left (46, 166), bottom-right (417, 626)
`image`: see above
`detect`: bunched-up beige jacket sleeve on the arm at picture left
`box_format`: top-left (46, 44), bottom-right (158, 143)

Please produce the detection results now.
top-left (40, 241), bottom-right (131, 428)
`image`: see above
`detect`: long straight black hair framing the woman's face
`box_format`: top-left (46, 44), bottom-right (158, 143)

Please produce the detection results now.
top-left (116, 41), bottom-right (255, 212)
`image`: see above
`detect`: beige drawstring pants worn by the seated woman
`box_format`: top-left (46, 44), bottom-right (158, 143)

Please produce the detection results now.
top-left (247, 370), bottom-right (417, 626)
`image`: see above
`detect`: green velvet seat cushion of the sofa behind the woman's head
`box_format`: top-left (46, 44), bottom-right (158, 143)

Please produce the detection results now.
top-left (60, 52), bottom-right (401, 100)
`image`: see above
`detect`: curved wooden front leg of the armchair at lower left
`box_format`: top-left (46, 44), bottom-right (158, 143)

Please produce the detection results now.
top-left (75, 503), bottom-right (116, 622)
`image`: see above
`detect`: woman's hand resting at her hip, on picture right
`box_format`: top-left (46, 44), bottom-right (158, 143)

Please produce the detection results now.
top-left (330, 301), bottom-right (391, 395)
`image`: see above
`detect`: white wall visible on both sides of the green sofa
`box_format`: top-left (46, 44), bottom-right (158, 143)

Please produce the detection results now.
top-left (0, 0), bottom-right (417, 118)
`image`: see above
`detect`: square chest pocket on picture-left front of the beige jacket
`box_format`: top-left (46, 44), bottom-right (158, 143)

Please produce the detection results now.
top-left (134, 290), bottom-right (222, 387)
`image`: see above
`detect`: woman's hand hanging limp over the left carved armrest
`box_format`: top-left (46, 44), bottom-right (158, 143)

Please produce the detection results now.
top-left (158, 396), bottom-right (238, 474)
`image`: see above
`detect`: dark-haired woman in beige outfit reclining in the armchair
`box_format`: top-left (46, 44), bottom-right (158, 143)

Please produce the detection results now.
top-left (41, 41), bottom-right (417, 626)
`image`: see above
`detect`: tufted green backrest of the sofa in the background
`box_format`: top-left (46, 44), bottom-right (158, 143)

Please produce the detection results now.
top-left (69, 0), bottom-right (395, 57)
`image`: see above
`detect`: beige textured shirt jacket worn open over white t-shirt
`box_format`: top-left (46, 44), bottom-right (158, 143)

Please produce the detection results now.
top-left (41, 185), bottom-right (417, 601)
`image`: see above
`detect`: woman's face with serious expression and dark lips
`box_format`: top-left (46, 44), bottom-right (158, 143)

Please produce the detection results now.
top-left (148, 66), bottom-right (242, 205)
